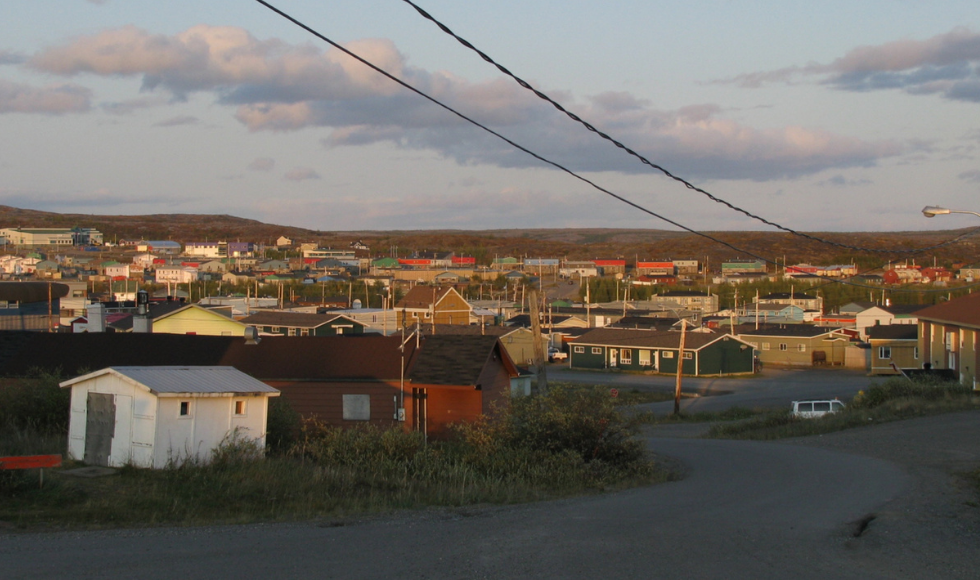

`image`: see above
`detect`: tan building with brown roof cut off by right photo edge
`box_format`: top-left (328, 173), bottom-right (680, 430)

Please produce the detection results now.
top-left (916, 293), bottom-right (980, 389)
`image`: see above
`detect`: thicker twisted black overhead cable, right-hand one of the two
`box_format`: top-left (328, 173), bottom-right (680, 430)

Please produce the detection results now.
top-left (402, 0), bottom-right (980, 255)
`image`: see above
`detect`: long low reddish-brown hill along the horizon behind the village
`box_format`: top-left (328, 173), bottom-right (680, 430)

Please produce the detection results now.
top-left (0, 206), bottom-right (980, 268)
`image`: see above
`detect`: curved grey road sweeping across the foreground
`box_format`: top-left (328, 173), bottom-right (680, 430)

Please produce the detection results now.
top-left (0, 438), bottom-right (910, 580)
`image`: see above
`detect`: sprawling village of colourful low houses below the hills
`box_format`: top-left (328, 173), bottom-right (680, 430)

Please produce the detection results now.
top-left (0, 228), bottom-right (980, 466)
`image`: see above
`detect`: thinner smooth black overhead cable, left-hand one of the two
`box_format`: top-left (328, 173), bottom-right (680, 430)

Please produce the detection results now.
top-left (255, 0), bottom-right (980, 288)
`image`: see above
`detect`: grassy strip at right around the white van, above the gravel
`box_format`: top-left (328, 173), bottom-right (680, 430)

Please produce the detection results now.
top-left (707, 379), bottom-right (980, 439)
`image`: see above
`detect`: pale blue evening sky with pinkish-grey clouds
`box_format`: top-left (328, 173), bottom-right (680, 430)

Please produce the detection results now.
top-left (0, 0), bottom-right (980, 232)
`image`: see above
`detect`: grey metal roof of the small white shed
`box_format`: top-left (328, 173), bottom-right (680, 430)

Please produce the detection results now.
top-left (61, 366), bottom-right (279, 395)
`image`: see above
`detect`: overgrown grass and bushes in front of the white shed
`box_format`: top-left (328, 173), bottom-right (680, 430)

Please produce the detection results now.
top-left (0, 386), bottom-right (669, 529)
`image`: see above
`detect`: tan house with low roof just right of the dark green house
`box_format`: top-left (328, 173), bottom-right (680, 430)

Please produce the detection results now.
top-left (738, 324), bottom-right (851, 366)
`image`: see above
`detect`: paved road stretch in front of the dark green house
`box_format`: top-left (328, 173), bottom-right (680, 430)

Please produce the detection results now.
top-left (548, 365), bottom-right (883, 413)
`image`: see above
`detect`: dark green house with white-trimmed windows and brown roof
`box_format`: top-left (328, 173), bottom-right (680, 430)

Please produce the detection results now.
top-left (569, 328), bottom-right (754, 376)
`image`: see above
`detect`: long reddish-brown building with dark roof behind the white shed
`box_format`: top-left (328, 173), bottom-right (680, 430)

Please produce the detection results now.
top-left (0, 333), bottom-right (518, 437)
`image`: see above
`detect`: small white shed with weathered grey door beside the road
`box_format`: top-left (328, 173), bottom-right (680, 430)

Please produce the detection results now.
top-left (61, 366), bottom-right (279, 468)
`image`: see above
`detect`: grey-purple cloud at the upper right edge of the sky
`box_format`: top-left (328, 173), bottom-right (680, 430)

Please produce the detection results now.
top-left (715, 27), bottom-right (980, 103)
